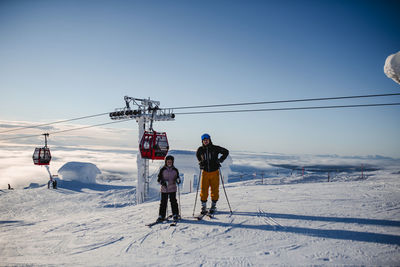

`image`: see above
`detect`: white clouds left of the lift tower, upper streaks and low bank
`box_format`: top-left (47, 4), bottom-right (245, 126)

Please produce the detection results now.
top-left (0, 121), bottom-right (141, 188)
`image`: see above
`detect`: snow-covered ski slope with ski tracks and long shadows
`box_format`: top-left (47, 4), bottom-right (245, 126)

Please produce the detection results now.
top-left (0, 152), bottom-right (400, 266)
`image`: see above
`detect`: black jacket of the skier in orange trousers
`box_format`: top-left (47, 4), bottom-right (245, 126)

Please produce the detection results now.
top-left (196, 140), bottom-right (229, 172)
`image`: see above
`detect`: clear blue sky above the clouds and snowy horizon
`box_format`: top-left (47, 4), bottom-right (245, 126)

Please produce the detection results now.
top-left (0, 0), bottom-right (400, 157)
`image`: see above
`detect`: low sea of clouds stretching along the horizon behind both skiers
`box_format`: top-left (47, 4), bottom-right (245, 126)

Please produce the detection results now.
top-left (0, 142), bottom-right (399, 191)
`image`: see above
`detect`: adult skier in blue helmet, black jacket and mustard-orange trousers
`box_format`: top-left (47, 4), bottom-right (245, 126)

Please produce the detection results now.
top-left (196, 134), bottom-right (229, 214)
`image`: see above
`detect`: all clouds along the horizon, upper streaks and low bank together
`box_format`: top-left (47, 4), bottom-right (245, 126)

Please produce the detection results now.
top-left (0, 118), bottom-right (398, 189)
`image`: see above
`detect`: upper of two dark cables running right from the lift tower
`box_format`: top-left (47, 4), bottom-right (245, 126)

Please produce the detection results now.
top-left (169, 93), bottom-right (400, 109)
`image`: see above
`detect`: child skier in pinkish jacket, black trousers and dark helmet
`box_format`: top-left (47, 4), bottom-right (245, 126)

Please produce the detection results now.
top-left (157, 155), bottom-right (181, 222)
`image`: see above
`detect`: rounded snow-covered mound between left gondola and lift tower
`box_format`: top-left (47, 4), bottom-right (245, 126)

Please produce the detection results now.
top-left (58, 162), bottom-right (101, 184)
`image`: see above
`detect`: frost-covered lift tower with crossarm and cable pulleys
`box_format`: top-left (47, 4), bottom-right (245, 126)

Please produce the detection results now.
top-left (110, 96), bottom-right (175, 204)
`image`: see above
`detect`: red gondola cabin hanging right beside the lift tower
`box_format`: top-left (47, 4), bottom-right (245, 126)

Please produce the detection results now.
top-left (139, 131), bottom-right (169, 160)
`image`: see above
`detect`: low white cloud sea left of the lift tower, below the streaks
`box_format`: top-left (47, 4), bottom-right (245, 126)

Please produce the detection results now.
top-left (0, 146), bottom-right (137, 189)
